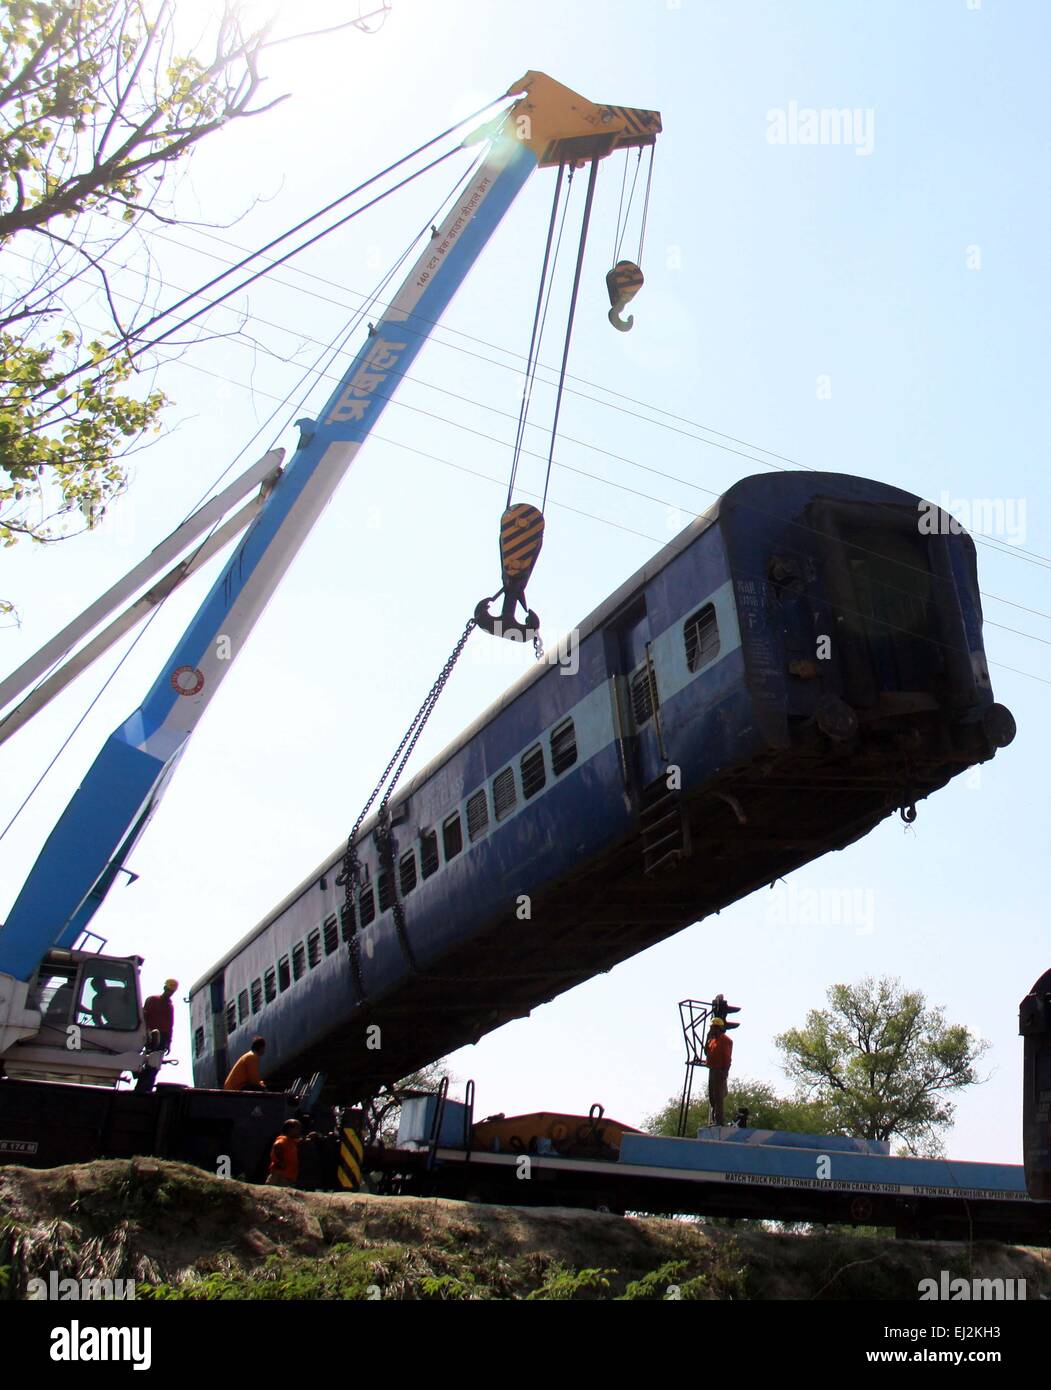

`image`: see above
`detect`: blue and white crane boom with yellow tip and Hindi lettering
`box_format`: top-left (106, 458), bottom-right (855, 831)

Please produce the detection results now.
top-left (0, 72), bottom-right (660, 1054)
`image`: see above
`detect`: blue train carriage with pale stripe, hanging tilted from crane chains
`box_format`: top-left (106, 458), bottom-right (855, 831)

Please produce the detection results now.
top-left (192, 471), bottom-right (1015, 1101)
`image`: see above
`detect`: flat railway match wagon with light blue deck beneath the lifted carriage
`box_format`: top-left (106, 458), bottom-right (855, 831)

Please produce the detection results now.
top-left (380, 1097), bottom-right (1051, 1245)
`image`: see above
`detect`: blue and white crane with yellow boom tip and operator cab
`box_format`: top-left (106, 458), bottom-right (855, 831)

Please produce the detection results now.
top-left (0, 71), bottom-right (662, 1086)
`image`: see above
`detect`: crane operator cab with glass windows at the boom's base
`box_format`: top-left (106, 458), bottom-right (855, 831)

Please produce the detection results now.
top-left (0, 949), bottom-right (146, 1086)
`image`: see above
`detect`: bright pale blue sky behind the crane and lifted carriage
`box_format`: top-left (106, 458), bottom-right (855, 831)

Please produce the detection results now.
top-left (0, 0), bottom-right (1051, 1162)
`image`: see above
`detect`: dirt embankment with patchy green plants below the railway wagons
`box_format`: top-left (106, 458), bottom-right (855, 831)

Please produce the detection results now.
top-left (0, 1159), bottom-right (1051, 1300)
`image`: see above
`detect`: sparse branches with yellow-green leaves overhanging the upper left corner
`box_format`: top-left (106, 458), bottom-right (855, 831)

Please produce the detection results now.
top-left (0, 0), bottom-right (291, 564)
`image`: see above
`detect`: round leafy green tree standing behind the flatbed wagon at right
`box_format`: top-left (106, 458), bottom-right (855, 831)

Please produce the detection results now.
top-left (776, 979), bottom-right (988, 1154)
